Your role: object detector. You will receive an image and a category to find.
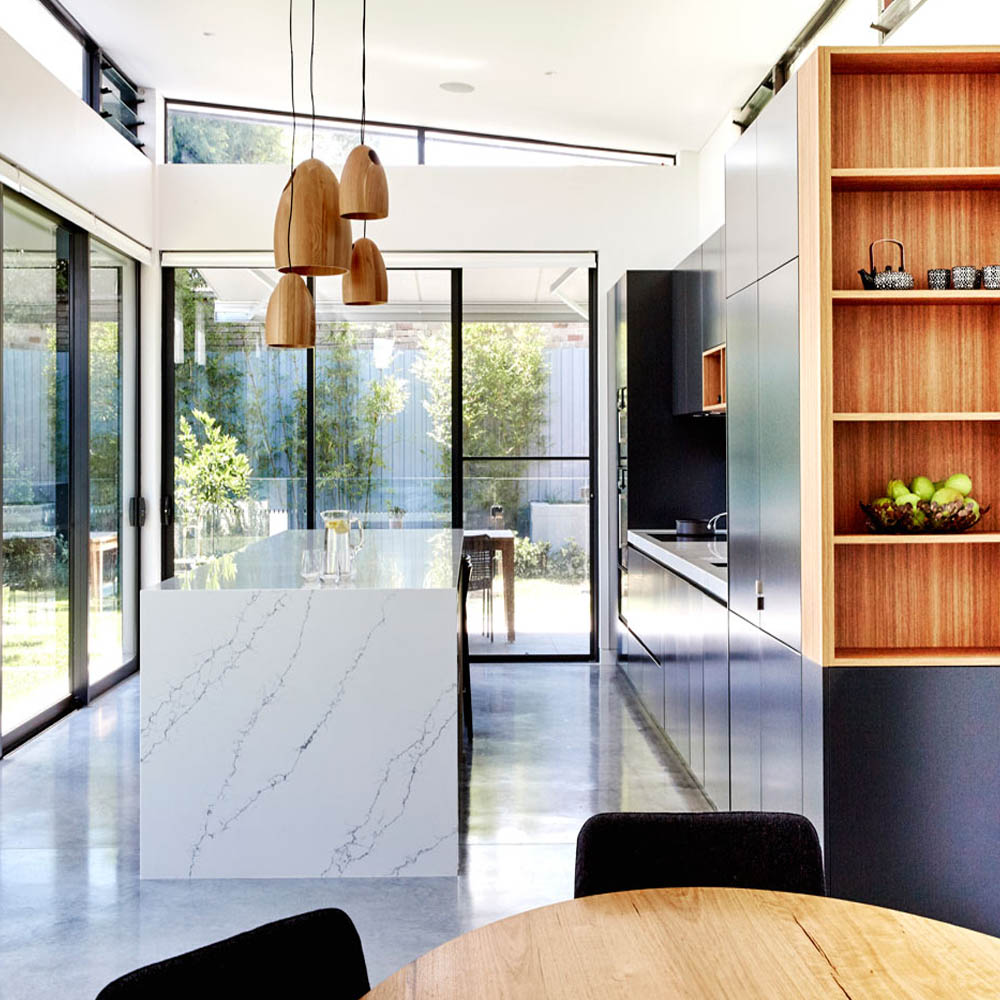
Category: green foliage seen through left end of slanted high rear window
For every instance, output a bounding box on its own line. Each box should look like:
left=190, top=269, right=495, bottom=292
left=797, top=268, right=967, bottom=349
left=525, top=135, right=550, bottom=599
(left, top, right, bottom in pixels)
left=167, top=111, right=288, bottom=163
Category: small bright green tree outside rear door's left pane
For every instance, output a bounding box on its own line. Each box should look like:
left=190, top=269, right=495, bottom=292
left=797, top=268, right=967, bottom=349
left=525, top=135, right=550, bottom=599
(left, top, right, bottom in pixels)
left=174, top=410, right=253, bottom=552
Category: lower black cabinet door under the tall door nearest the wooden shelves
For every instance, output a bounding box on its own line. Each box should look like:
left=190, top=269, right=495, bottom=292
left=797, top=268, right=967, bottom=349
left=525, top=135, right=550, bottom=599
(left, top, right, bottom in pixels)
left=760, top=632, right=802, bottom=813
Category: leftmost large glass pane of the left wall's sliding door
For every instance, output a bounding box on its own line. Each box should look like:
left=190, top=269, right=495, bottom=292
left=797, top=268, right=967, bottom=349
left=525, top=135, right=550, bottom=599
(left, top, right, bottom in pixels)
left=0, top=196, right=70, bottom=732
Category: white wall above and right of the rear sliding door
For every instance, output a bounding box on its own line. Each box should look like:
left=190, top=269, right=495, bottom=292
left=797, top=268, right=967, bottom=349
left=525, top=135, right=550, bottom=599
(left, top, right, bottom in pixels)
left=158, top=156, right=698, bottom=648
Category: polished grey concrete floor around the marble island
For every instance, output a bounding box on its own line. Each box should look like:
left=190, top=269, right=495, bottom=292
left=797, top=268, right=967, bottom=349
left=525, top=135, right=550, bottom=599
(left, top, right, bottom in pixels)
left=0, top=663, right=708, bottom=1000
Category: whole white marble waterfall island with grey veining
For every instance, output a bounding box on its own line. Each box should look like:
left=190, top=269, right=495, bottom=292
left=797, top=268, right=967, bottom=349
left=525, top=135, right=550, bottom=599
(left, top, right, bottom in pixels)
left=139, top=530, right=462, bottom=878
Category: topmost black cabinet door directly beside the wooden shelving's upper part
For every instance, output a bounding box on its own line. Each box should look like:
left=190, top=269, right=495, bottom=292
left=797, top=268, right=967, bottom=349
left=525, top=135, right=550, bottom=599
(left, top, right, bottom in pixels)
left=754, top=76, right=799, bottom=277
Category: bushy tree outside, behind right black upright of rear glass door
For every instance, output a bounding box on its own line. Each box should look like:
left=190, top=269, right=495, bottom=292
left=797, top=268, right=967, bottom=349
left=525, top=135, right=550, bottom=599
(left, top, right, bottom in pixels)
left=415, top=323, right=549, bottom=525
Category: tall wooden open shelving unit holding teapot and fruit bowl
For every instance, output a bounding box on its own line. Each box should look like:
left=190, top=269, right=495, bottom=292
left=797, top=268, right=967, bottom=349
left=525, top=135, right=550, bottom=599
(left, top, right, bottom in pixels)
left=799, top=47, right=1000, bottom=667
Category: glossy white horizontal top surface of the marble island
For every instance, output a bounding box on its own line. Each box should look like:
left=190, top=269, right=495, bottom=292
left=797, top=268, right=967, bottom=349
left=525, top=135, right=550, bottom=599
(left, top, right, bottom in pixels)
left=153, top=528, right=462, bottom=590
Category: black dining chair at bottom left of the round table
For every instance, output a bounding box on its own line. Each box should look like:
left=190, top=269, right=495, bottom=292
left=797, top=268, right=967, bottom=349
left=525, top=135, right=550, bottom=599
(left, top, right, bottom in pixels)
left=97, top=909, right=370, bottom=1000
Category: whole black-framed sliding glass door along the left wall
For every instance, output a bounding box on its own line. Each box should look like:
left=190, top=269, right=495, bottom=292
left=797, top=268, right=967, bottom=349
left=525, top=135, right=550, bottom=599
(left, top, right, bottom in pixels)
left=0, top=191, right=139, bottom=749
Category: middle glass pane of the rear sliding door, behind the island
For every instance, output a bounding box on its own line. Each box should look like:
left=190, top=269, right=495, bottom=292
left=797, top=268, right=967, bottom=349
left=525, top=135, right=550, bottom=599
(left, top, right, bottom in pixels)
left=316, top=270, right=451, bottom=528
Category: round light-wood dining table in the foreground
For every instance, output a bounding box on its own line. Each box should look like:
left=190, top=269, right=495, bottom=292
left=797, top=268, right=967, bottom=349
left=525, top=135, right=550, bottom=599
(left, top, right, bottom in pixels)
left=368, top=889, right=1000, bottom=1000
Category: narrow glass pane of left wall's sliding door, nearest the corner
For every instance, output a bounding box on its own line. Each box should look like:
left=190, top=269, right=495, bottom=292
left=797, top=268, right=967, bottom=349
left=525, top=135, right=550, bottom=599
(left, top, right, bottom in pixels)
left=87, top=240, right=138, bottom=684
